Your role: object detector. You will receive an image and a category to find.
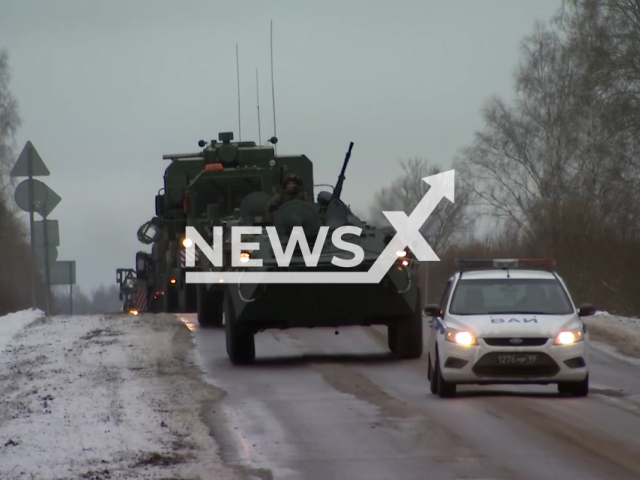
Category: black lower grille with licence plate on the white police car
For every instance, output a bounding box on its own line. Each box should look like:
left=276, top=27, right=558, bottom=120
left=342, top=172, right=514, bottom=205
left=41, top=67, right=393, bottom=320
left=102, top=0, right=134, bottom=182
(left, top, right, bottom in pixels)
left=473, top=351, right=560, bottom=377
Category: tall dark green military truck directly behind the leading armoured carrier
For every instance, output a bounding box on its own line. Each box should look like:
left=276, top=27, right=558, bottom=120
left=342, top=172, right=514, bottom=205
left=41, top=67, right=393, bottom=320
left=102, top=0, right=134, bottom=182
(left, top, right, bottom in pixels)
left=176, top=132, right=313, bottom=327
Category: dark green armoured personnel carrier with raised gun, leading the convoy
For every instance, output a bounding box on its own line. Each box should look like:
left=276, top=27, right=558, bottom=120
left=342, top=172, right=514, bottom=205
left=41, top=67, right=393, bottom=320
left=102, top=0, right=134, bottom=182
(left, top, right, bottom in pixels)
left=218, top=144, right=425, bottom=364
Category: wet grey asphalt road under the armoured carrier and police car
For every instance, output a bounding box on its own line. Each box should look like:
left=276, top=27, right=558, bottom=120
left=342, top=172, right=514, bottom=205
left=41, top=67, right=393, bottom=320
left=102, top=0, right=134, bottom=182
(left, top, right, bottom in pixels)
left=180, top=315, right=640, bottom=480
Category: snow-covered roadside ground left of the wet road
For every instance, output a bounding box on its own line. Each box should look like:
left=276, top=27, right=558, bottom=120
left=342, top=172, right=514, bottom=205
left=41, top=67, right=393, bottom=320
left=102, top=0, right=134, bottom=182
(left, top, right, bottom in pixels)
left=0, top=311, right=240, bottom=480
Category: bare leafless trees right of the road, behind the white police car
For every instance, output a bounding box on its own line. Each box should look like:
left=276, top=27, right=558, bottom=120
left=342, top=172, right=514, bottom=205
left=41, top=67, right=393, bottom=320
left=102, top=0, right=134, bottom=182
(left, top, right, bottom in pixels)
left=372, top=0, right=640, bottom=315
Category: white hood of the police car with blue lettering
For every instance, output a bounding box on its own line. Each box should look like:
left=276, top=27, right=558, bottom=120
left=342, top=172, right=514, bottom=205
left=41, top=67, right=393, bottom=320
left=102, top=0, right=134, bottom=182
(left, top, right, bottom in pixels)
left=445, top=313, right=582, bottom=337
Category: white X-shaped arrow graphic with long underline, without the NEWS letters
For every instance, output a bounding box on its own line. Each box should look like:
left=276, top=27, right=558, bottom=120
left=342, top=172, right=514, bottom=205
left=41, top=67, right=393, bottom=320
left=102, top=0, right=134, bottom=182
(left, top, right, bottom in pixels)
left=185, top=170, right=455, bottom=284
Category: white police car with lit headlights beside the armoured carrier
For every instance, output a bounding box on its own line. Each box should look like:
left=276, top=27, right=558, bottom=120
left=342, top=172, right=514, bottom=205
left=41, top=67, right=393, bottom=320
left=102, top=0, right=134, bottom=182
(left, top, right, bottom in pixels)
left=425, top=259, right=595, bottom=397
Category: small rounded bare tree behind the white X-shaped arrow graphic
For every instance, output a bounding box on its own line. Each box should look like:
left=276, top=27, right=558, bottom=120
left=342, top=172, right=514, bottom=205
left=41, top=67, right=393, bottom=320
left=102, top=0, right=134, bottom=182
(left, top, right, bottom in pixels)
left=371, top=158, right=471, bottom=252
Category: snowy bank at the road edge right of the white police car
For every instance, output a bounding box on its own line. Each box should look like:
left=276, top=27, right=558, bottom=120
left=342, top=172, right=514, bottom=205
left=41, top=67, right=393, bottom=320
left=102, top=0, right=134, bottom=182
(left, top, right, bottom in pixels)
left=584, top=312, right=640, bottom=357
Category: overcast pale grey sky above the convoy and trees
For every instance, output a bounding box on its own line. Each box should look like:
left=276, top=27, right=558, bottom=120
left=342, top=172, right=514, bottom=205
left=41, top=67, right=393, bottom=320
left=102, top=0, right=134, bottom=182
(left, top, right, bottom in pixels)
left=0, top=0, right=561, bottom=290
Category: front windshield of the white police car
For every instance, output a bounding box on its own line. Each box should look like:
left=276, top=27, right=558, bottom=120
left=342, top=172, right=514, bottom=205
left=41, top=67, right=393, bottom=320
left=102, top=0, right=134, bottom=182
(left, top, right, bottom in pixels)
left=449, top=278, right=574, bottom=315
